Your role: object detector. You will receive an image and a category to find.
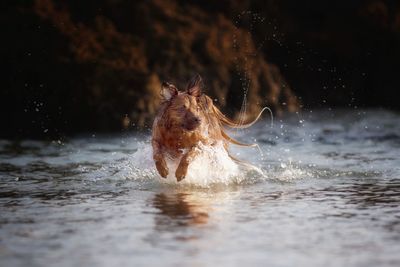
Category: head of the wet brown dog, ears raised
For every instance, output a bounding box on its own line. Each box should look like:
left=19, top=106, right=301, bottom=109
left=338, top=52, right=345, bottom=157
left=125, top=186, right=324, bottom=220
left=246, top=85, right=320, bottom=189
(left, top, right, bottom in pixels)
left=161, top=75, right=206, bottom=131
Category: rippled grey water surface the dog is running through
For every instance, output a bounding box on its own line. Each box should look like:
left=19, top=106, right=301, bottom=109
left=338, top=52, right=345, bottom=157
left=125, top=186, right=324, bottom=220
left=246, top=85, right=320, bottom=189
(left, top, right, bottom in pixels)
left=0, top=110, right=400, bottom=266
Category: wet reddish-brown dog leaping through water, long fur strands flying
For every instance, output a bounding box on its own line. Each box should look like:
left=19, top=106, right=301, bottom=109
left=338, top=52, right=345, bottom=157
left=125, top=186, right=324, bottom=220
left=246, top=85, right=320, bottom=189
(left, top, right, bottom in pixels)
left=152, top=75, right=261, bottom=181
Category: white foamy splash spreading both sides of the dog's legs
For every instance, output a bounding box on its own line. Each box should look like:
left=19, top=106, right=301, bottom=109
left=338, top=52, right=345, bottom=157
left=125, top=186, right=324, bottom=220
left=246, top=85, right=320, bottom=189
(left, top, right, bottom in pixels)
left=85, top=141, right=312, bottom=188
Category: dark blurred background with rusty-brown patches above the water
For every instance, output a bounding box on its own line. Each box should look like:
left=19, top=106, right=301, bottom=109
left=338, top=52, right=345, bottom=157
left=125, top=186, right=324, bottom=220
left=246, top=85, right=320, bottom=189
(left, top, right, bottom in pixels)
left=0, top=0, right=400, bottom=139
